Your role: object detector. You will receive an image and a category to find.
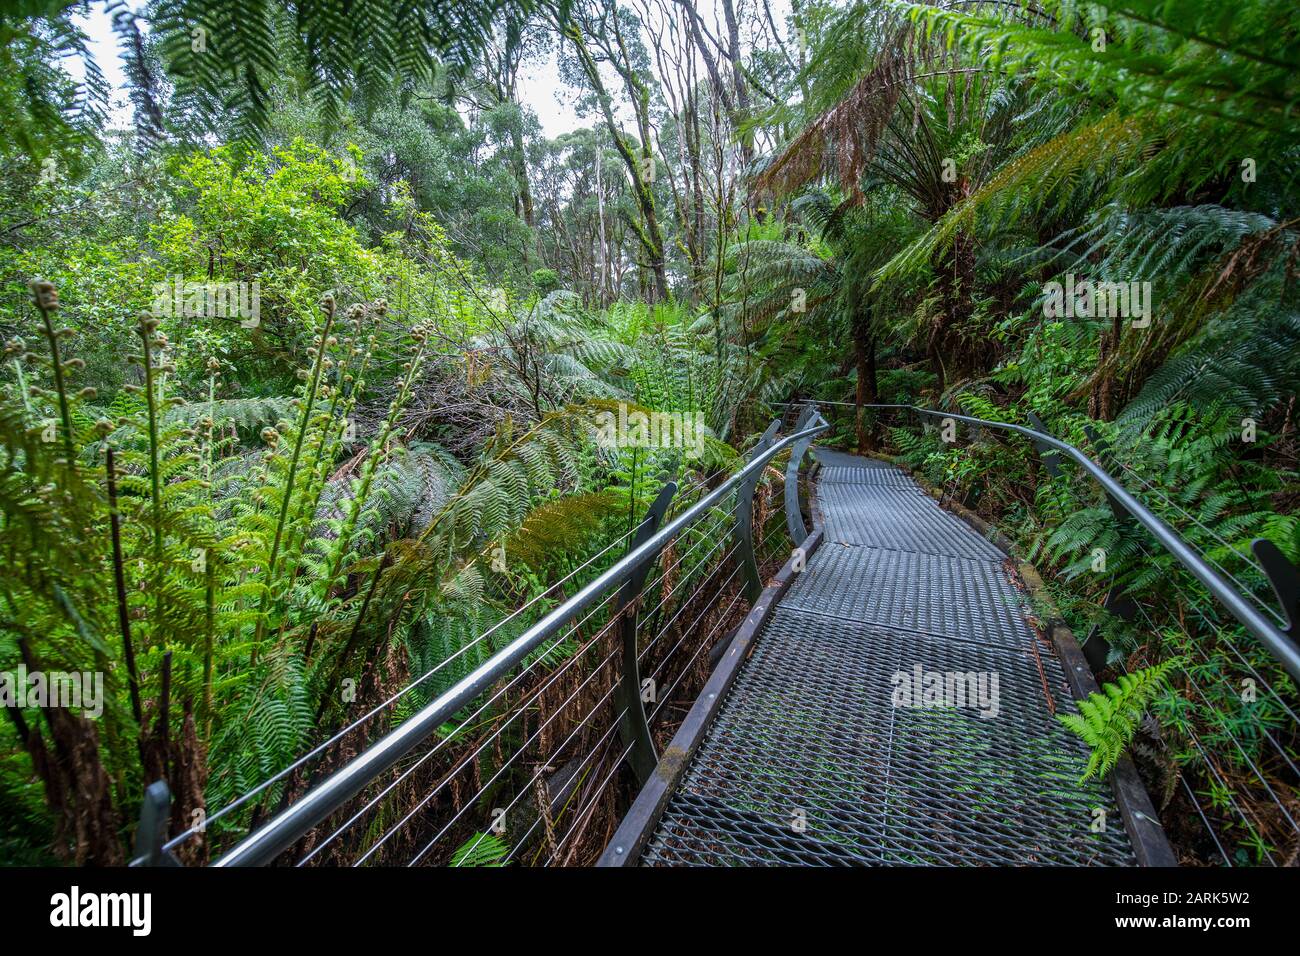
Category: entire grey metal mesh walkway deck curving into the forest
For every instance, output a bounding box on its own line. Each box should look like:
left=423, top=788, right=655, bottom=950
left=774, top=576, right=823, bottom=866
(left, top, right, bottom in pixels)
left=641, top=453, right=1134, bottom=865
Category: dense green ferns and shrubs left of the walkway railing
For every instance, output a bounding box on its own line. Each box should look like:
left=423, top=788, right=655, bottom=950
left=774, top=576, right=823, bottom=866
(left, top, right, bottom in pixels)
left=3, top=143, right=769, bottom=862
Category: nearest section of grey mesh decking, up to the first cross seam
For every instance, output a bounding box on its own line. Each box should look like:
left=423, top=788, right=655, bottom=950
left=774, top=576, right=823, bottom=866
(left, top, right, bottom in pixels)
left=642, top=606, right=1134, bottom=866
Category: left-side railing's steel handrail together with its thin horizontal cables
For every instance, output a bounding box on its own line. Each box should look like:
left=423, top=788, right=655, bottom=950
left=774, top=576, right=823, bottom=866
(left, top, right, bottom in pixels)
left=157, top=420, right=828, bottom=866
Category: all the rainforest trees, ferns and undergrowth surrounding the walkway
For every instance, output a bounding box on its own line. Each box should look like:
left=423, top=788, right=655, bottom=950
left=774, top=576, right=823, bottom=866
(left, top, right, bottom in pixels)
left=0, top=0, right=1300, bottom=865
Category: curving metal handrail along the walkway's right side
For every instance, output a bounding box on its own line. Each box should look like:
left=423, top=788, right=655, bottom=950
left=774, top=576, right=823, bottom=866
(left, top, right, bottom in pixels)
left=810, top=399, right=1300, bottom=684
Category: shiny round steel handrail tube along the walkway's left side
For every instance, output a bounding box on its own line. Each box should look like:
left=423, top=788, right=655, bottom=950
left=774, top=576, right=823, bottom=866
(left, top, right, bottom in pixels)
left=213, top=419, right=829, bottom=866
